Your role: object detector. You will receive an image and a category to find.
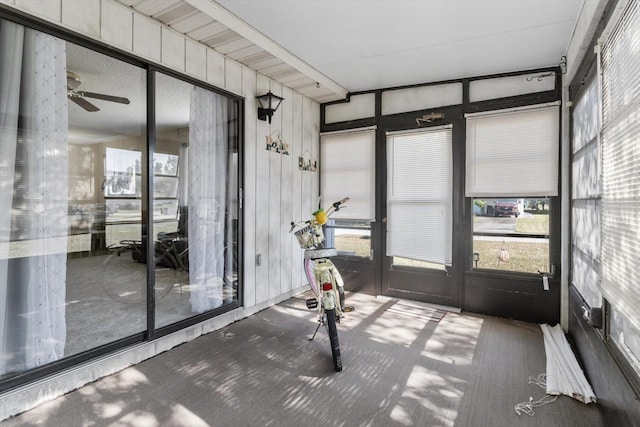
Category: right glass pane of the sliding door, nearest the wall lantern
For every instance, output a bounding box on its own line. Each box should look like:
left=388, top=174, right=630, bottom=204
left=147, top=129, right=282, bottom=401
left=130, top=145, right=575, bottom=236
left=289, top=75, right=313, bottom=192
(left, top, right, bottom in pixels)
left=153, top=74, right=238, bottom=327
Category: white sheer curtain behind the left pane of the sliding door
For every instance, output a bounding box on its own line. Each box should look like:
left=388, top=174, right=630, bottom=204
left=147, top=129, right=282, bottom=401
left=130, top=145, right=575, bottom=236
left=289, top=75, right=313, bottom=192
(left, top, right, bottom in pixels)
left=0, top=20, right=68, bottom=375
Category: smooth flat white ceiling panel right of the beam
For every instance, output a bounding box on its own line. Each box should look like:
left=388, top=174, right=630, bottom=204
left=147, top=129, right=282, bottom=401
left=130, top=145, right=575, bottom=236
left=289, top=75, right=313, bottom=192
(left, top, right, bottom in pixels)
left=219, top=0, right=584, bottom=92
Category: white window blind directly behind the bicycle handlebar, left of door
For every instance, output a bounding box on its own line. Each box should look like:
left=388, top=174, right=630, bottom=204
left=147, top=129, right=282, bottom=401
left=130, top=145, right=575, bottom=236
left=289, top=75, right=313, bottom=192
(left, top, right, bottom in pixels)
left=320, top=128, right=376, bottom=221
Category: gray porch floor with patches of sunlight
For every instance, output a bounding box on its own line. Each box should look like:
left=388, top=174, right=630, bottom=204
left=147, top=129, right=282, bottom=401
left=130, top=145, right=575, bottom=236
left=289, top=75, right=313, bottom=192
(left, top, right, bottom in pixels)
left=0, top=294, right=604, bottom=427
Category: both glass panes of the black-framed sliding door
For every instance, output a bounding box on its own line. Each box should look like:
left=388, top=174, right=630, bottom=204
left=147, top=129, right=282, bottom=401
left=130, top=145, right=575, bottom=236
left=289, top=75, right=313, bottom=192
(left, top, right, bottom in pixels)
left=0, top=34, right=238, bottom=378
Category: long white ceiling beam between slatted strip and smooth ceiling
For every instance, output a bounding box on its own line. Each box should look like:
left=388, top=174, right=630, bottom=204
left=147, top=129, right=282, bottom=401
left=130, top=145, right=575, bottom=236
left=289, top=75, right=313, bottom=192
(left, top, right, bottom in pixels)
left=185, top=0, right=349, bottom=99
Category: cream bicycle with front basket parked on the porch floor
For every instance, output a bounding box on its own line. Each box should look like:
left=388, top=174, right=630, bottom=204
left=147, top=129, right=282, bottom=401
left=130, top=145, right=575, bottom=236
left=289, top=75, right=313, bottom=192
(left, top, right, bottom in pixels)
left=289, top=197, right=354, bottom=372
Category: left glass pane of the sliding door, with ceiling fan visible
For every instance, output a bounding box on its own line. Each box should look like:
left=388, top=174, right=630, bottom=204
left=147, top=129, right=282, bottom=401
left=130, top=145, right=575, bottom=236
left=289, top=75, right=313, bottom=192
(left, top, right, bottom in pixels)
left=0, top=20, right=146, bottom=379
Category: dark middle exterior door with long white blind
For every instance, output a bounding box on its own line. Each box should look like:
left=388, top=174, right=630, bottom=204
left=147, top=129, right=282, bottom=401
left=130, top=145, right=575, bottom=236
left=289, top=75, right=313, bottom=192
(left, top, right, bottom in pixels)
left=381, top=125, right=460, bottom=306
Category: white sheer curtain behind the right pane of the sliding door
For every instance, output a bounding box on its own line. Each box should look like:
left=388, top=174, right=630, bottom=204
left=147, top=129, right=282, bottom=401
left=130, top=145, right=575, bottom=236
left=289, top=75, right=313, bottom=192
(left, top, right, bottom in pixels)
left=188, top=87, right=229, bottom=313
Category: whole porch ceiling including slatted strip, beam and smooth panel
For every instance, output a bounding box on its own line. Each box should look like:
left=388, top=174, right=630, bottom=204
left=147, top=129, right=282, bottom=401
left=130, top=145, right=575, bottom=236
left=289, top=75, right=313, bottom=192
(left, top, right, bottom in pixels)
left=117, top=0, right=598, bottom=103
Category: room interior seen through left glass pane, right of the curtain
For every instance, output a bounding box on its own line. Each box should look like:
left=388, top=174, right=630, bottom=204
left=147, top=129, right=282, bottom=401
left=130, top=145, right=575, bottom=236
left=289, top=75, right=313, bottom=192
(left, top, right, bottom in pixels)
left=65, top=43, right=147, bottom=356
